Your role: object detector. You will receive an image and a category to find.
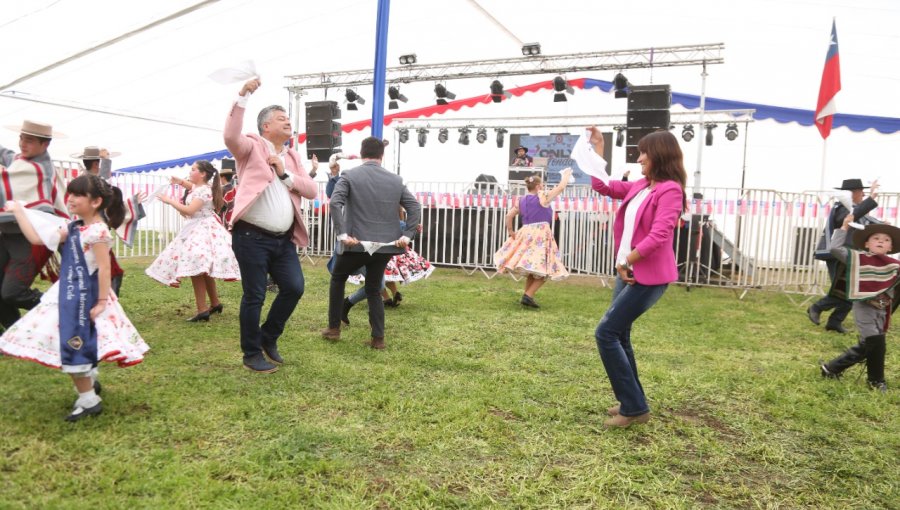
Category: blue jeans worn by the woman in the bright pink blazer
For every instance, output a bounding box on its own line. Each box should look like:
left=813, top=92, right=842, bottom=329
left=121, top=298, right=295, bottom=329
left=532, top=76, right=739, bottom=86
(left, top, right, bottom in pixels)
left=594, top=278, right=668, bottom=416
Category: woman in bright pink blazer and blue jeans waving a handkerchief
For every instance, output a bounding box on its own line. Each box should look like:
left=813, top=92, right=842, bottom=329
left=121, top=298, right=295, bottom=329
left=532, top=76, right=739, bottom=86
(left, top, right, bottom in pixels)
left=590, top=128, right=687, bottom=427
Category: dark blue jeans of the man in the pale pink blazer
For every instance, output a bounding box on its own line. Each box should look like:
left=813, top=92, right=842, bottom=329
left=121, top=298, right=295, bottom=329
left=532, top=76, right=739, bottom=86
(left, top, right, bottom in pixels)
left=231, top=225, right=304, bottom=359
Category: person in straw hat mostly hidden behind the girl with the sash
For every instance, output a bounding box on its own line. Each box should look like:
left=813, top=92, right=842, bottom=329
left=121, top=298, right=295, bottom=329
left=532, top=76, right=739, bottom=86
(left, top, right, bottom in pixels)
left=72, top=146, right=147, bottom=297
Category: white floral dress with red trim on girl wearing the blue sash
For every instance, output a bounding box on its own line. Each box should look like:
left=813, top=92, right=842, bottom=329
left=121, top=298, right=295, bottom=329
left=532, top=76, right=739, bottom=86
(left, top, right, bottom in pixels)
left=0, top=223, right=150, bottom=368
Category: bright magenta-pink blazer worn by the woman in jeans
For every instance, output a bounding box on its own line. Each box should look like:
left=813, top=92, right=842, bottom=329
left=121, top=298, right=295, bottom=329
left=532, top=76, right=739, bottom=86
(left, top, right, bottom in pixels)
left=591, top=177, right=684, bottom=285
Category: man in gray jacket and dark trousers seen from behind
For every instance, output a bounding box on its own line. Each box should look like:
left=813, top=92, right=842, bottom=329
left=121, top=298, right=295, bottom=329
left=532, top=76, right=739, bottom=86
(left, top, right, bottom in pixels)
left=322, top=137, right=422, bottom=349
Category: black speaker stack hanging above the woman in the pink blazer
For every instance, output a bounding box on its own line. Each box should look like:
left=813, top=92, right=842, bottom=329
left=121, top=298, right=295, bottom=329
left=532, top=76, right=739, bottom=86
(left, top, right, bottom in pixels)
left=625, top=85, right=672, bottom=163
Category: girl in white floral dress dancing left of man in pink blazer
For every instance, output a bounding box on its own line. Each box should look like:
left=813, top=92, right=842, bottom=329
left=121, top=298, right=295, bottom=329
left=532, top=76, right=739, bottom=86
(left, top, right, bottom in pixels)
left=145, top=160, right=241, bottom=322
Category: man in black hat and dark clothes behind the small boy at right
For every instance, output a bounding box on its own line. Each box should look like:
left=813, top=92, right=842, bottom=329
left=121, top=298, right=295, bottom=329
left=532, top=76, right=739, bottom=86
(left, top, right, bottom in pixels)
left=806, top=179, right=878, bottom=333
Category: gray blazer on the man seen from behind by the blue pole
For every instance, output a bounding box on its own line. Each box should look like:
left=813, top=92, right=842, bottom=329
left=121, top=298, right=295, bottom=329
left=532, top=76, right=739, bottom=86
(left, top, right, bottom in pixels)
left=329, top=161, right=422, bottom=254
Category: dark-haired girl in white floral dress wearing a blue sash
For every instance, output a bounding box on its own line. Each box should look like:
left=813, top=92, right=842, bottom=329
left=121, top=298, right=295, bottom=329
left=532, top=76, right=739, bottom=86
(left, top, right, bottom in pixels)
left=0, top=174, right=150, bottom=422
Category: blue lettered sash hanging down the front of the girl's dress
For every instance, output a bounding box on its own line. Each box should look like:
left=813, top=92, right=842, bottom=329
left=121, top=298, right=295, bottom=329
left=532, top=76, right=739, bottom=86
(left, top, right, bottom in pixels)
left=59, top=221, right=99, bottom=372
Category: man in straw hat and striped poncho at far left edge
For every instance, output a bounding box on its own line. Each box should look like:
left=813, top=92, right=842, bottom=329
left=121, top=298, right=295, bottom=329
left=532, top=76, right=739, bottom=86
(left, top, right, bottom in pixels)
left=0, top=120, right=68, bottom=328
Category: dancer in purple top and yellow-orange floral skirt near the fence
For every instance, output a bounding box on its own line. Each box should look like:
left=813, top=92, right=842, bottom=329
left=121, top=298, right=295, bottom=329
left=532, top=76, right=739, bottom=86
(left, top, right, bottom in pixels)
left=494, top=168, right=572, bottom=308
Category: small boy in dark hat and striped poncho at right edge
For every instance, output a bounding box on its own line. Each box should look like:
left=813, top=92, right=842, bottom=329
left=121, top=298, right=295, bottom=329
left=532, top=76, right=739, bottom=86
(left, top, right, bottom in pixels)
left=819, top=214, right=900, bottom=392
